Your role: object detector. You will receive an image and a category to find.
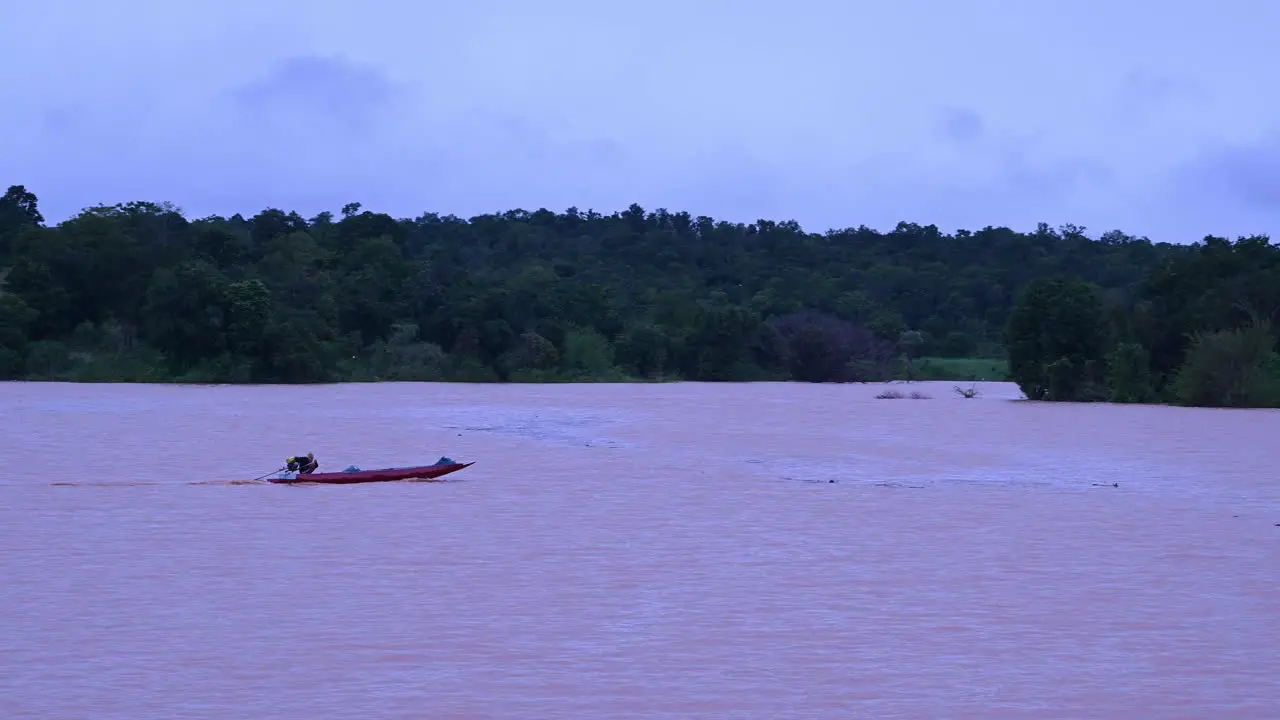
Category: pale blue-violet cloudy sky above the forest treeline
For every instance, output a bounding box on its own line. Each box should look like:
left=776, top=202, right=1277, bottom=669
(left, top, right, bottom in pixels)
left=0, top=0, right=1280, bottom=242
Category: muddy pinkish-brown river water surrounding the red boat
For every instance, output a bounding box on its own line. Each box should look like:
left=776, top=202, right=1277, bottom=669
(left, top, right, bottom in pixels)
left=0, top=383, right=1280, bottom=719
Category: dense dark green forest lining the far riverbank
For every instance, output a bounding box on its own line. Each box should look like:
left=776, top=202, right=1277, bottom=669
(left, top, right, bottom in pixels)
left=0, top=186, right=1280, bottom=405
